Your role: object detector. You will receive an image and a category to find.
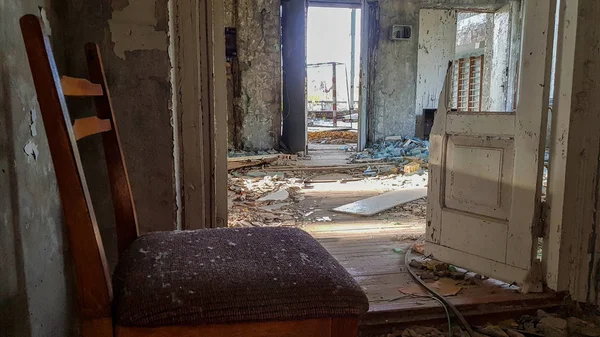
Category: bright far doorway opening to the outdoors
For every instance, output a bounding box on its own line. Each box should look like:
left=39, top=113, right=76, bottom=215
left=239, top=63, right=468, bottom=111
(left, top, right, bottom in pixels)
left=306, top=6, right=361, bottom=150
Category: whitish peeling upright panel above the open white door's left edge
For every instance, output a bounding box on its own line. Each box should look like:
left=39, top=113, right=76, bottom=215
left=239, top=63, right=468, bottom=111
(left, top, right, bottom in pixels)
left=415, top=9, right=456, bottom=136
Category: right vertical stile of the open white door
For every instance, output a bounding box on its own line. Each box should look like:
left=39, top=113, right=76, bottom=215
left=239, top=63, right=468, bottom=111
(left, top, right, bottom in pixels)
left=506, top=0, right=556, bottom=269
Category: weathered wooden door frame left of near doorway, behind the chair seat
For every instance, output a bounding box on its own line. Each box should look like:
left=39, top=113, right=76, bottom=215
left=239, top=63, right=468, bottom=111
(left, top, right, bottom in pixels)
left=169, top=0, right=227, bottom=229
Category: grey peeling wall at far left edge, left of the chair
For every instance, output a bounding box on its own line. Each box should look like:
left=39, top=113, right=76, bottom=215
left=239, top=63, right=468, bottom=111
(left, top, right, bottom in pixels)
left=0, top=0, right=77, bottom=337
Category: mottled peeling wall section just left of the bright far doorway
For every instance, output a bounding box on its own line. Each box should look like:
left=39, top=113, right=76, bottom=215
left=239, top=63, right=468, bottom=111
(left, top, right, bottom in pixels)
left=224, top=0, right=281, bottom=150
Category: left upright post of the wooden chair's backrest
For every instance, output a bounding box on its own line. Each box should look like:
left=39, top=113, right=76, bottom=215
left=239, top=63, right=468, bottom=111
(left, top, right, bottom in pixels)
left=20, top=15, right=112, bottom=319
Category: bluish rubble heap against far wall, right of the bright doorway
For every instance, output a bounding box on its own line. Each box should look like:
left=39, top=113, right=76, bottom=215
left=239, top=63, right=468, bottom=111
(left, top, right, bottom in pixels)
left=351, top=136, right=429, bottom=163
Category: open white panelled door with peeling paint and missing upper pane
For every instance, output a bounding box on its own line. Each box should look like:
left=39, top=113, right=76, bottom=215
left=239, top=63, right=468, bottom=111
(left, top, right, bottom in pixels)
left=425, top=0, right=556, bottom=292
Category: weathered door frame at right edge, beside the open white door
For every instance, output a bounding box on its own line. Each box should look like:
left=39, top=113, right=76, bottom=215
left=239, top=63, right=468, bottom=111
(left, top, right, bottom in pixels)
left=542, top=0, right=600, bottom=304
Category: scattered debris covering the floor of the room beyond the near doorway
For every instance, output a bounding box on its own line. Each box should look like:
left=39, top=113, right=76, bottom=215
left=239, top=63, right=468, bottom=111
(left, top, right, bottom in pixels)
left=228, top=144, right=428, bottom=226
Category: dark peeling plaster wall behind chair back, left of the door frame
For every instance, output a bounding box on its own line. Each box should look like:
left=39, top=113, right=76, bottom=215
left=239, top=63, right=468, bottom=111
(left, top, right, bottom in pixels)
left=66, top=0, right=177, bottom=265
